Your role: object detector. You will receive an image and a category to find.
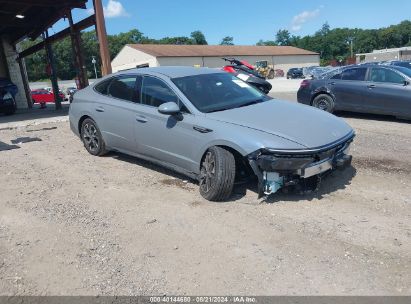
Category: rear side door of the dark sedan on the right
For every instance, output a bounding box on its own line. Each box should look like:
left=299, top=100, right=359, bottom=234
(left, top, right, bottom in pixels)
left=327, top=67, right=367, bottom=111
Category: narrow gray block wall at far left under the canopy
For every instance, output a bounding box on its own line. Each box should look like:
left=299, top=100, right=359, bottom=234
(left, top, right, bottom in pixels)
left=0, top=38, right=28, bottom=109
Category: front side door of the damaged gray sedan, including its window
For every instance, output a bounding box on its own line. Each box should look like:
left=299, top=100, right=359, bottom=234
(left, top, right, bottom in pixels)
left=135, top=76, right=201, bottom=172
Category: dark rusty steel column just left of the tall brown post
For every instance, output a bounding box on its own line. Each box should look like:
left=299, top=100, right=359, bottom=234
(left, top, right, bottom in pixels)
left=67, top=11, right=88, bottom=89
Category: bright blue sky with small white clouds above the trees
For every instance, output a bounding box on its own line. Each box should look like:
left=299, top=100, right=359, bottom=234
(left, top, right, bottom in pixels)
left=51, top=0, right=411, bottom=45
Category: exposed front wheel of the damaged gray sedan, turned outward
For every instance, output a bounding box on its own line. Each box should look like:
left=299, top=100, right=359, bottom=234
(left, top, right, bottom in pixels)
left=200, top=146, right=236, bottom=202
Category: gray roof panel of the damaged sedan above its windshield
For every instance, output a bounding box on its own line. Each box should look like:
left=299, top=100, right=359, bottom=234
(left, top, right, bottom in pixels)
left=117, top=66, right=224, bottom=78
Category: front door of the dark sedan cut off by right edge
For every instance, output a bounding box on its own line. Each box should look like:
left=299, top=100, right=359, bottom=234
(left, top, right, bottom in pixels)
left=365, top=67, right=411, bottom=116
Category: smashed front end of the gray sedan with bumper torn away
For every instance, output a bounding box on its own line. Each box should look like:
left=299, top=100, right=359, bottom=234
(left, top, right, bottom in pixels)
left=248, top=133, right=355, bottom=197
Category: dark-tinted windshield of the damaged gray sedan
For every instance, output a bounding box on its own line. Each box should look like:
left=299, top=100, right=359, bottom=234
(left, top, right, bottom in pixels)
left=172, top=73, right=271, bottom=113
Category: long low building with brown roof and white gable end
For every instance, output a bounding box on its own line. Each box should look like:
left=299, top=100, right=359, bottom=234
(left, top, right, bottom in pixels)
left=111, top=44, right=320, bottom=72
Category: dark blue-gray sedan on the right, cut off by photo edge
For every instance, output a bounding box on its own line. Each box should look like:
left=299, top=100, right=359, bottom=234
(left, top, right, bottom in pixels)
left=297, top=65, right=411, bottom=119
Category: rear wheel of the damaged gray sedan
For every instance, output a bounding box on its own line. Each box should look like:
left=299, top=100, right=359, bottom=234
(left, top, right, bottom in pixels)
left=80, top=118, right=107, bottom=156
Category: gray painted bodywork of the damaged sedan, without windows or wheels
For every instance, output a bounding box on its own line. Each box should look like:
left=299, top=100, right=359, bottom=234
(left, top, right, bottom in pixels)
left=69, top=67, right=353, bottom=176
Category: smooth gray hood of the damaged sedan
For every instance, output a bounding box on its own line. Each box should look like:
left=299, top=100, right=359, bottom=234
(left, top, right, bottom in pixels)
left=207, top=99, right=353, bottom=149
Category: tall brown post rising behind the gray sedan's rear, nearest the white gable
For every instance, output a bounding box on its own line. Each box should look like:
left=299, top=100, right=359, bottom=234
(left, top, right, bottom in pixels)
left=93, top=0, right=112, bottom=76
